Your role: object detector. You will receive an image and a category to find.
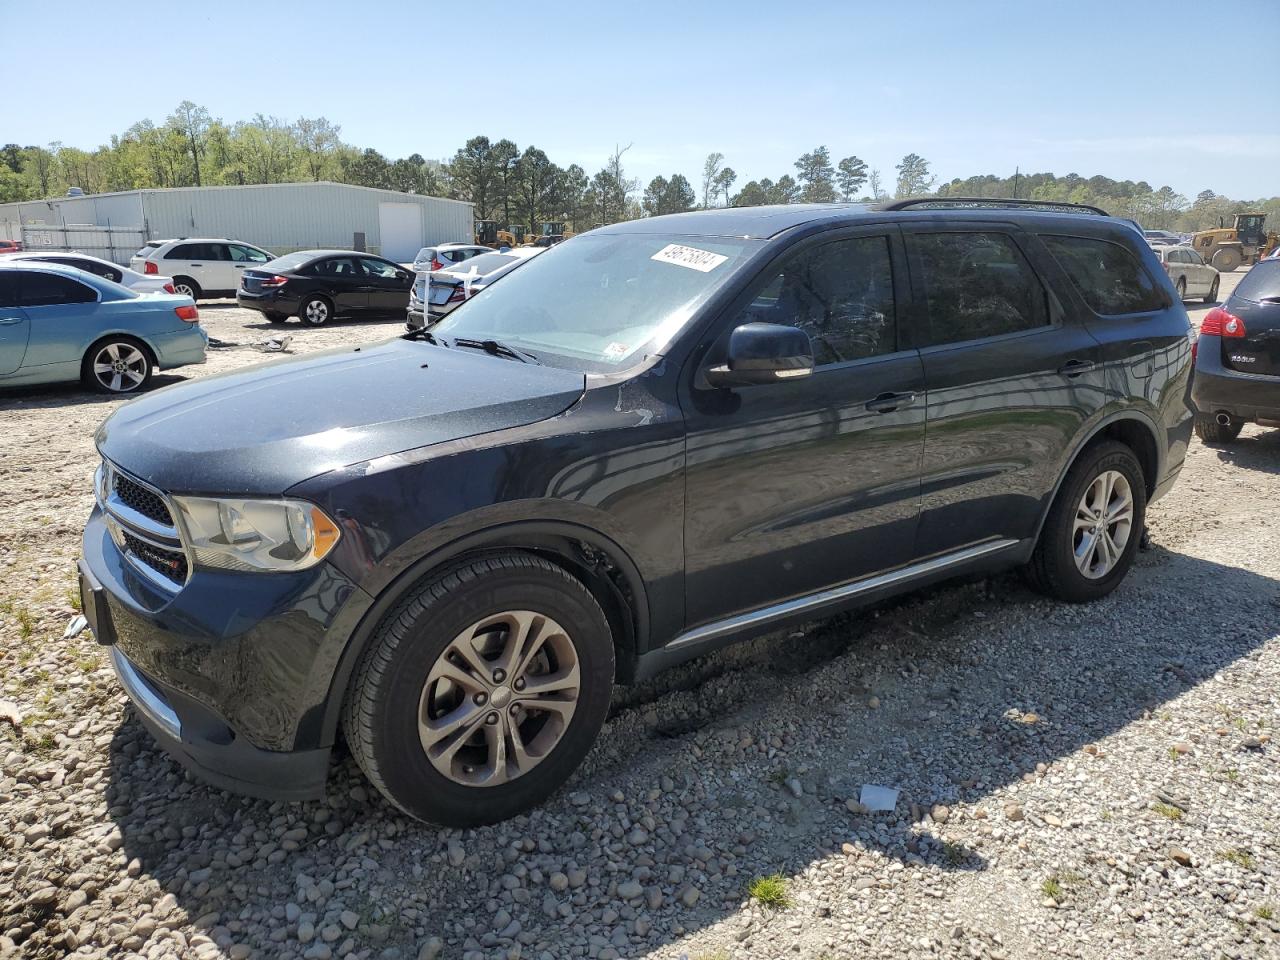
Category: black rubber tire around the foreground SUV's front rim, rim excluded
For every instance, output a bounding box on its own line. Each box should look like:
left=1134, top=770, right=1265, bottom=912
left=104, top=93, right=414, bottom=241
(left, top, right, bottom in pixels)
left=343, top=553, right=613, bottom=827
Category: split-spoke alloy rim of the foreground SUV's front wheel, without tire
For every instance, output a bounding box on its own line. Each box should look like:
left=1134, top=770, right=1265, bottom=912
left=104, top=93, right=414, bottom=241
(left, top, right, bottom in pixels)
left=417, top=611, right=581, bottom=787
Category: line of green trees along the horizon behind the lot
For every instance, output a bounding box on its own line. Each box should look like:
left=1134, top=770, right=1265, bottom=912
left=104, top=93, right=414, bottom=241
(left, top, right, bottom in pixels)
left=0, top=100, right=1280, bottom=232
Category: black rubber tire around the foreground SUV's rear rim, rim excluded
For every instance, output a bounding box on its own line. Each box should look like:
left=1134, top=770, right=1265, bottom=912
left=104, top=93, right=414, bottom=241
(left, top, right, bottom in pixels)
left=1027, top=440, right=1147, bottom=603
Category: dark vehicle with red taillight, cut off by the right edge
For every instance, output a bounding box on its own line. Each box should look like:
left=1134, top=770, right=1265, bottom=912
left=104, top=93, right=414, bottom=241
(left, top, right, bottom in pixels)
left=1192, top=260, right=1280, bottom=443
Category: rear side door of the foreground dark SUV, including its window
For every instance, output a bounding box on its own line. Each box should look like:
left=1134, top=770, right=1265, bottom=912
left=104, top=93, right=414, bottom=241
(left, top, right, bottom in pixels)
left=904, top=221, right=1105, bottom=556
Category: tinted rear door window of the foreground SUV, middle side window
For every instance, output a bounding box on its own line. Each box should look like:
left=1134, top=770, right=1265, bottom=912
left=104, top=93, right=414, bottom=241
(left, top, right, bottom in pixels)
left=914, top=232, right=1050, bottom=346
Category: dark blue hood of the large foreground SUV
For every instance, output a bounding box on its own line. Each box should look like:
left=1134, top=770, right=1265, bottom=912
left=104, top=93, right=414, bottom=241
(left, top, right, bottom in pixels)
left=97, top=339, right=585, bottom=495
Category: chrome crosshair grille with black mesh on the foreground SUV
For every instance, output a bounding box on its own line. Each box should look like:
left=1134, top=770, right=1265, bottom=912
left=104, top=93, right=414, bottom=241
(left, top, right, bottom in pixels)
left=93, top=460, right=191, bottom=591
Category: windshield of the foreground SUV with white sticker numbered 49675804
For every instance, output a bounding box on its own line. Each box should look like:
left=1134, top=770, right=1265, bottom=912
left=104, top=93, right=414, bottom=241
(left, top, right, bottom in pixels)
left=431, top=233, right=759, bottom=374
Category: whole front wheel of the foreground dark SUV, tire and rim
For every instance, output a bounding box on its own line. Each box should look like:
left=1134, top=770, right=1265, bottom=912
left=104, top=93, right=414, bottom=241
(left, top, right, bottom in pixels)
left=343, top=553, right=613, bottom=827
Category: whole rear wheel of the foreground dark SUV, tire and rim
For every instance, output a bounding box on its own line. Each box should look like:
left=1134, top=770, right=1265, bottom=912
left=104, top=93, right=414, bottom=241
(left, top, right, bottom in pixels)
left=1027, top=440, right=1147, bottom=603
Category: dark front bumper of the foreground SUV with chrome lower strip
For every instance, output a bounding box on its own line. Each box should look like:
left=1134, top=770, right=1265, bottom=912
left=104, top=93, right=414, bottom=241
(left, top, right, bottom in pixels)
left=81, top=508, right=369, bottom=800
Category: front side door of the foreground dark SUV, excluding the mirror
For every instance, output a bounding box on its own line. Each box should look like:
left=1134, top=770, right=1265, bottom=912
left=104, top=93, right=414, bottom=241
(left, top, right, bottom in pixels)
left=680, top=225, right=924, bottom=626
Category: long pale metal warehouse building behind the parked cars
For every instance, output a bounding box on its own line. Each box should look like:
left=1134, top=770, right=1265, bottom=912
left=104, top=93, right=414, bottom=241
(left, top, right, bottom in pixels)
left=0, top=182, right=474, bottom=264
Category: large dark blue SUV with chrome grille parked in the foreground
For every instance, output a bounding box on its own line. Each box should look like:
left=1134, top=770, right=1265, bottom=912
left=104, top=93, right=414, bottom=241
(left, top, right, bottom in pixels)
left=81, top=201, right=1192, bottom=824
